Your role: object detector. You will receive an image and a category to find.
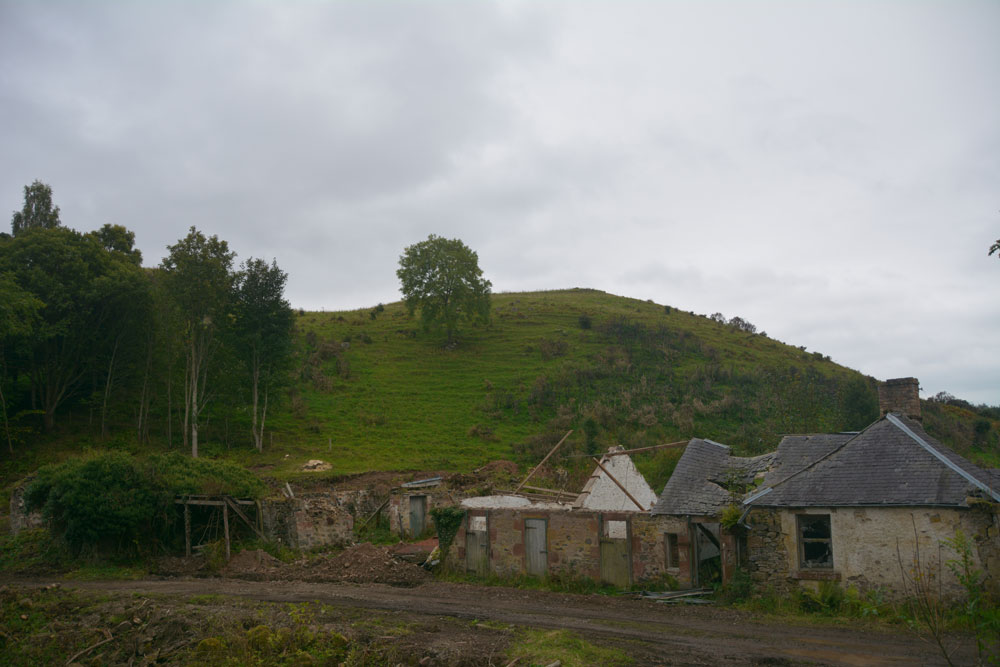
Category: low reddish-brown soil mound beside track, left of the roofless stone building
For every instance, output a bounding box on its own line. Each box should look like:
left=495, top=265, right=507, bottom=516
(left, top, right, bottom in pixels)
left=276, top=542, right=429, bottom=586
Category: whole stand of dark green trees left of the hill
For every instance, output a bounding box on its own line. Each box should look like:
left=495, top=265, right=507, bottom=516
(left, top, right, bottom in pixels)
left=0, top=181, right=294, bottom=457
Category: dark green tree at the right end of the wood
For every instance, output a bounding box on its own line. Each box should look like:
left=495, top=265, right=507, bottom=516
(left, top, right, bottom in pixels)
left=234, top=258, right=295, bottom=451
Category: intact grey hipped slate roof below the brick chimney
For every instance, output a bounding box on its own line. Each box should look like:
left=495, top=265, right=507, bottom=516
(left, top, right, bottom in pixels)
left=745, top=414, right=1000, bottom=507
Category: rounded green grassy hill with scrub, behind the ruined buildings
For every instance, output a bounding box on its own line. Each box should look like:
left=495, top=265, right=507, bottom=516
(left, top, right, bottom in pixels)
left=8, top=289, right=1000, bottom=490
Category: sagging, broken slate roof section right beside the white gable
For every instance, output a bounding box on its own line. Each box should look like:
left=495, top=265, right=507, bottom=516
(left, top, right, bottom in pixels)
left=651, top=438, right=774, bottom=516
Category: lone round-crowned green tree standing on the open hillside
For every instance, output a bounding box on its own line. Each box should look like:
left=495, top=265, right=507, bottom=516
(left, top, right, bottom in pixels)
left=396, top=234, right=491, bottom=344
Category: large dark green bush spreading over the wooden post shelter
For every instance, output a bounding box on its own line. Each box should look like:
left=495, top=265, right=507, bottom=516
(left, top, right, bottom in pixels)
left=25, top=452, right=265, bottom=554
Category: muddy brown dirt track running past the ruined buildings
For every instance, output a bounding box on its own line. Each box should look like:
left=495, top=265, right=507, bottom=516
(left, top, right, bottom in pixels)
left=35, top=578, right=972, bottom=665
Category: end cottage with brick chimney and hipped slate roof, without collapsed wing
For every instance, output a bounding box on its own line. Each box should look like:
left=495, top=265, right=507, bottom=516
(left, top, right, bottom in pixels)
left=741, top=378, right=1000, bottom=596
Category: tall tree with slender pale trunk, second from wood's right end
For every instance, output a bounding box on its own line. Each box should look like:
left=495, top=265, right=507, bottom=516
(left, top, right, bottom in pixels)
left=160, top=227, right=235, bottom=458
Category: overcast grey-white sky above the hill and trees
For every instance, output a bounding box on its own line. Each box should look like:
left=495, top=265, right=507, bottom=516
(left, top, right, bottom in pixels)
left=0, top=0, right=1000, bottom=404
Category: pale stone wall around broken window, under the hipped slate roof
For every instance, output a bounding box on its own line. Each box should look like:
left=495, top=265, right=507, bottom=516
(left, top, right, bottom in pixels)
left=747, top=506, right=1000, bottom=598
